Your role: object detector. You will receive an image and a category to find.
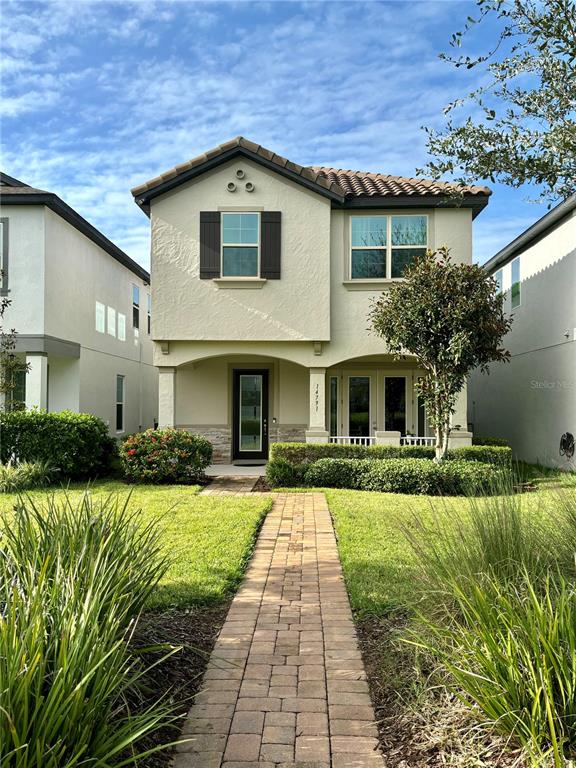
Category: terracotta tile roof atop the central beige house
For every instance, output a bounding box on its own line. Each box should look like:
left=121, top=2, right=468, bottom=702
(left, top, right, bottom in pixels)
left=132, top=136, right=491, bottom=204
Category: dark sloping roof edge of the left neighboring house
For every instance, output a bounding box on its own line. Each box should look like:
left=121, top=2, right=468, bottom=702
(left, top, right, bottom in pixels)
left=0, top=172, right=150, bottom=284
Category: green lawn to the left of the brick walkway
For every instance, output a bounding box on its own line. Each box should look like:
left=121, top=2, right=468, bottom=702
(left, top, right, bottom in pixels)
left=0, top=482, right=271, bottom=609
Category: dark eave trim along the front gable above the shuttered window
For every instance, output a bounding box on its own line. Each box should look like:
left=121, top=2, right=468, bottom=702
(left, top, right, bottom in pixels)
left=132, top=146, right=345, bottom=216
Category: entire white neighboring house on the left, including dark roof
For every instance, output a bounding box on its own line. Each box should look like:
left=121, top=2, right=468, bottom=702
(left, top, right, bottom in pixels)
left=0, top=174, right=158, bottom=435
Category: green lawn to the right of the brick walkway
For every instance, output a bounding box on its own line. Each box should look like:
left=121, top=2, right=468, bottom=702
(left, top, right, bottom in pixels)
left=325, top=464, right=574, bottom=615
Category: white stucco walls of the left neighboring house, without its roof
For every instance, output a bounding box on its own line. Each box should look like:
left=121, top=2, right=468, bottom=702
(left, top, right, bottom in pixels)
left=1, top=205, right=158, bottom=435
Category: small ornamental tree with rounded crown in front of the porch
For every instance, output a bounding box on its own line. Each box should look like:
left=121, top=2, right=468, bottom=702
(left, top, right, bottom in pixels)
left=369, top=248, right=511, bottom=461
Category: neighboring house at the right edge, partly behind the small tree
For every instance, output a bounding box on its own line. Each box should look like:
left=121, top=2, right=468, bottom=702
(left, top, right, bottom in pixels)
left=468, top=195, right=576, bottom=468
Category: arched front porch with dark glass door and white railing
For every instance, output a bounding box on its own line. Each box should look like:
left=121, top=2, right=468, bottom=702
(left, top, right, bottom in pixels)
left=159, top=355, right=471, bottom=465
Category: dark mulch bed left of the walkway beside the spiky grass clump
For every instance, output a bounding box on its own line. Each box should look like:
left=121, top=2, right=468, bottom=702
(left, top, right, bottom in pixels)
left=132, top=602, right=229, bottom=768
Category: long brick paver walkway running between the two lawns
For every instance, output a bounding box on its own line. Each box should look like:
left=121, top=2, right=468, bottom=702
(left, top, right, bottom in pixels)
left=174, top=493, right=384, bottom=768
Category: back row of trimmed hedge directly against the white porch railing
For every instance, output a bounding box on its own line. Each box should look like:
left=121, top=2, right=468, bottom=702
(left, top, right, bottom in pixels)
left=270, top=443, right=512, bottom=467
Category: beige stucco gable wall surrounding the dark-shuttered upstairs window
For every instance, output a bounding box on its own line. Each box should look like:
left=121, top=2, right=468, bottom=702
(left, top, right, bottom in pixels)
left=151, top=159, right=330, bottom=341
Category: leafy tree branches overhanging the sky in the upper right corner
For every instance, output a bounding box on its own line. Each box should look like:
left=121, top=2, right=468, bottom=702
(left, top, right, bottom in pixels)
left=418, top=0, right=576, bottom=202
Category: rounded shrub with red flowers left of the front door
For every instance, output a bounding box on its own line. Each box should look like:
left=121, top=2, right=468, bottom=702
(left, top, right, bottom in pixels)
left=120, top=429, right=212, bottom=484
